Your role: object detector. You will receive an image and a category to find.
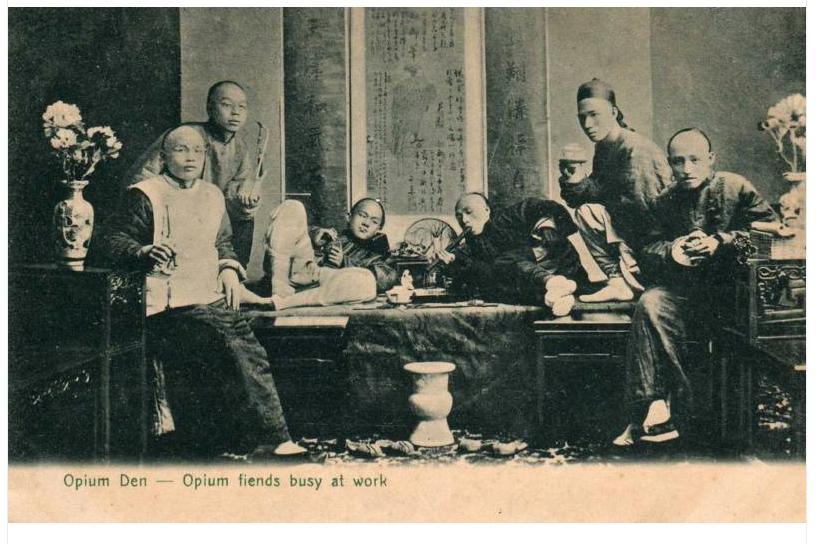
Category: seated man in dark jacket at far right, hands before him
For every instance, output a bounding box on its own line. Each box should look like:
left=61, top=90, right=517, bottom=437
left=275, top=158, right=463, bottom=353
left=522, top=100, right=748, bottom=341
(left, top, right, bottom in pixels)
left=613, top=128, right=776, bottom=446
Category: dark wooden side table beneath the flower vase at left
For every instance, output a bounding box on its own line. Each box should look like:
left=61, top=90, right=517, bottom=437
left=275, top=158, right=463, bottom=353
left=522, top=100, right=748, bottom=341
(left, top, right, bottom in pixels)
left=9, top=265, right=147, bottom=459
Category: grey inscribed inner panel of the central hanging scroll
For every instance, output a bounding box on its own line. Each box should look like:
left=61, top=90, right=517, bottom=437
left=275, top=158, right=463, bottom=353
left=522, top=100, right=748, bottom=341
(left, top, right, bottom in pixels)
left=365, top=8, right=467, bottom=215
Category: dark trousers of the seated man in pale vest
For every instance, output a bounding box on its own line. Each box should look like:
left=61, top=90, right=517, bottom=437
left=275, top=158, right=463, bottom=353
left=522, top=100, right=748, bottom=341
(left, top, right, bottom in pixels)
left=147, top=299, right=290, bottom=447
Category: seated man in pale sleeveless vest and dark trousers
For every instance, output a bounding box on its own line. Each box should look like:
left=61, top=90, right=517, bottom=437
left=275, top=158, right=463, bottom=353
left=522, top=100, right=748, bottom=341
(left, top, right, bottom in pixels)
left=106, top=125, right=305, bottom=455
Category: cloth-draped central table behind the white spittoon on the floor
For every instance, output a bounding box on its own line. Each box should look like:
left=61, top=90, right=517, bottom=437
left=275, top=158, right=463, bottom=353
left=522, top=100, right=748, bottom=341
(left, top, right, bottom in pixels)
left=153, top=302, right=547, bottom=436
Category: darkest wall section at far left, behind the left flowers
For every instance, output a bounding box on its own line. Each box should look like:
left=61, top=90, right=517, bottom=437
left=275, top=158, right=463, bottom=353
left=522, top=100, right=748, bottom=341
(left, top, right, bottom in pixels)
left=8, top=8, right=180, bottom=262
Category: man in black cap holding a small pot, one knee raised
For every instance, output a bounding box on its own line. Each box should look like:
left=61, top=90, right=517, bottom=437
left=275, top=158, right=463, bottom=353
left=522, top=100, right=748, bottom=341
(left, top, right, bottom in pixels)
left=560, top=79, right=672, bottom=302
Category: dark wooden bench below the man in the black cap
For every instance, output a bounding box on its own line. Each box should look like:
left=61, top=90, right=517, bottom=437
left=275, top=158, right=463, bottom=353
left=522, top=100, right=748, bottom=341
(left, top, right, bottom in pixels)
left=534, top=302, right=716, bottom=442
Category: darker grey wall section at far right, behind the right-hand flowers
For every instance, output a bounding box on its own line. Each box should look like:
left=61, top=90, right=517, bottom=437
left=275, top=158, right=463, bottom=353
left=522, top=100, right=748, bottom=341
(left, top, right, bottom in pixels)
left=650, top=8, right=806, bottom=202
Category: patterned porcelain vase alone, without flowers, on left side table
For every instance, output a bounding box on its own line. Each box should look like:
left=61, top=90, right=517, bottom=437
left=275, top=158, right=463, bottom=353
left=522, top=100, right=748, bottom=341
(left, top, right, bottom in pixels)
left=54, top=179, right=94, bottom=271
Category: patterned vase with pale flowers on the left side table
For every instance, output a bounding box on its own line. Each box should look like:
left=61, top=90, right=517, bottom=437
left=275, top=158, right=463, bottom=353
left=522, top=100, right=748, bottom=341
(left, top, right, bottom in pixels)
left=43, top=101, right=123, bottom=270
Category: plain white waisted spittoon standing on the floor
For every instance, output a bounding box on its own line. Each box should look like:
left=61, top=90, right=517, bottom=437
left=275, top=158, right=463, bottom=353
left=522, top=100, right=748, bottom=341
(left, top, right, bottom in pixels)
left=403, top=362, right=455, bottom=447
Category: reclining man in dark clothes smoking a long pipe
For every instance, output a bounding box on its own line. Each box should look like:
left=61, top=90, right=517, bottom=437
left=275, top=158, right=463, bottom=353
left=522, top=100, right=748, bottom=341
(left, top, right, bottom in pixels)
left=436, top=193, right=587, bottom=316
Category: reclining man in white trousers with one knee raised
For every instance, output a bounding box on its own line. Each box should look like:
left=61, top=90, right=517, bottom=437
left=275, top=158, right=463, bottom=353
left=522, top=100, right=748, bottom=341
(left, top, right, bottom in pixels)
left=251, top=197, right=398, bottom=310
